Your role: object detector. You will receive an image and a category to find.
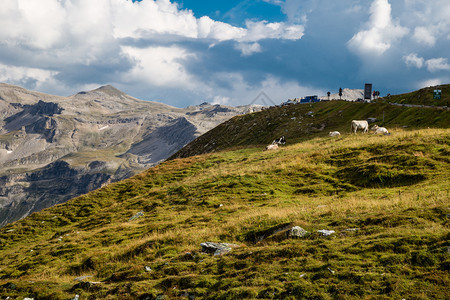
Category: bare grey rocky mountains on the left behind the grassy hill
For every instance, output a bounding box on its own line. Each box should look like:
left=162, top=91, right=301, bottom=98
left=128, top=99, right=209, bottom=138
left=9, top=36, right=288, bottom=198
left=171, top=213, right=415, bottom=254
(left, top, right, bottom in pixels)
left=0, top=84, right=258, bottom=226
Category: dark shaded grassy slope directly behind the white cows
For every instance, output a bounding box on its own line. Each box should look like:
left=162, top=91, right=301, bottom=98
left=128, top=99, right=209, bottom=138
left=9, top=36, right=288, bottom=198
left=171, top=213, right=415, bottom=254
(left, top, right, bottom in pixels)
left=172, top=101, right=450, bottom=158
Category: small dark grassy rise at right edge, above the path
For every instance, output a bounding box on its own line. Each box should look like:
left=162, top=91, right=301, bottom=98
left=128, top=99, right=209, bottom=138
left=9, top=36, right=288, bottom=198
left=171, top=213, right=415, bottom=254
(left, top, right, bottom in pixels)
left=378, top=84, right=450, bottom=107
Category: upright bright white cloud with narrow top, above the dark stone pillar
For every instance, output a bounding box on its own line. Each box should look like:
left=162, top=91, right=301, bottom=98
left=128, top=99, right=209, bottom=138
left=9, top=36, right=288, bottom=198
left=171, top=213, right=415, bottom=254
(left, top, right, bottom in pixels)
left=347, top=0, right=408, bottom=57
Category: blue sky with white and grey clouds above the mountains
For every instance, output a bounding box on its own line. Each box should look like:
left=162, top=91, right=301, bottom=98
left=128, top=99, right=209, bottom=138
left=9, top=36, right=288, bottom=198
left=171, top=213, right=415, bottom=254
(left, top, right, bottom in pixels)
left=0, top=0, right=450, bottom=107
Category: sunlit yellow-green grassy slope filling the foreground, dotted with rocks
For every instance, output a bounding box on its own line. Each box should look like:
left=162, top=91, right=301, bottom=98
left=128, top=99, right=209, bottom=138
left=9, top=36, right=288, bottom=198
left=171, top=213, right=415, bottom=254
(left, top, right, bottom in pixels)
left=0, top=127, right=450, bottom=299
